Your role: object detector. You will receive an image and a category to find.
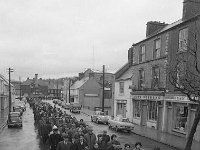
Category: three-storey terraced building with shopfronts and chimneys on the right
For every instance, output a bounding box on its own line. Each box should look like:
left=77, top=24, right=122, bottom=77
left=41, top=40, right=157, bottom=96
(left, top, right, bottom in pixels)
left=129, top=0, right=200, bottom=141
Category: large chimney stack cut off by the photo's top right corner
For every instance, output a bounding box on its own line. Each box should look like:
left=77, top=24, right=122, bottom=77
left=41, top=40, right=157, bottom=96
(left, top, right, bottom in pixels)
left=182, top=0, right=200, bottom=21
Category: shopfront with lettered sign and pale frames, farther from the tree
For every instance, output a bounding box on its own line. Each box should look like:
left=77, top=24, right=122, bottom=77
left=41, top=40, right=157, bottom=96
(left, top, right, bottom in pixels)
left=132, top=95, right=164, bottom=130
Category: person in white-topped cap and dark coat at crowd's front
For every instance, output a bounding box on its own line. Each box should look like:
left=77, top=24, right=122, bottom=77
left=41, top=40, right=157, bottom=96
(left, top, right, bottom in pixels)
left=49, top=125, right=62, bottom=150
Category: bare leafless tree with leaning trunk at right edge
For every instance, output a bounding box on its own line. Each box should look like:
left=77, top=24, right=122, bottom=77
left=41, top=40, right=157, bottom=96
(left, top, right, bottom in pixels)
left=168, top=17, right=200, bottom=150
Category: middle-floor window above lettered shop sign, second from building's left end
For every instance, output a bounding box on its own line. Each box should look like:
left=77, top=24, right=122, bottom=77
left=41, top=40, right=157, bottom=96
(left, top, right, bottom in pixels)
left=152, top=66, right=160, bottom=88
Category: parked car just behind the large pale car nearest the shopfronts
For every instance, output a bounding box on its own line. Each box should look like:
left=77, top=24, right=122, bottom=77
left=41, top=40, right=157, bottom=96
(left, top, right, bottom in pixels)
left=91, top=111, right=111, bottom=124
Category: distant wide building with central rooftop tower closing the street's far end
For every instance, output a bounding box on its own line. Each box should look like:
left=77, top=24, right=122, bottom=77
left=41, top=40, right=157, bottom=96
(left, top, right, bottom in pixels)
left=21, top=74, right=48, bottom=97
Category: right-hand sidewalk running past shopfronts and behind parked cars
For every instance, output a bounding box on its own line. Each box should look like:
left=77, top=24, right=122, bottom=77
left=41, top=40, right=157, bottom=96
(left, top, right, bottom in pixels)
left=81, top=108, right=200, bottom=150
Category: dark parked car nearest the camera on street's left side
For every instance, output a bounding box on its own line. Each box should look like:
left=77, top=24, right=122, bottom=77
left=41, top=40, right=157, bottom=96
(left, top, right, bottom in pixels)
left=7, top=112, right=22, bottom=128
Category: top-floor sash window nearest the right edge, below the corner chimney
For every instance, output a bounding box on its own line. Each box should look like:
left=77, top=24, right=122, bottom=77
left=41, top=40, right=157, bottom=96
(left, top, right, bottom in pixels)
left=178, top=28, right=188, bottom=51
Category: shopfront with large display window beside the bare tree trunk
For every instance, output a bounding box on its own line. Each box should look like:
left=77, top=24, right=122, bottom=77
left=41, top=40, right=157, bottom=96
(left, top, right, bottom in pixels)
left=165, top=94, right=200, bottom=141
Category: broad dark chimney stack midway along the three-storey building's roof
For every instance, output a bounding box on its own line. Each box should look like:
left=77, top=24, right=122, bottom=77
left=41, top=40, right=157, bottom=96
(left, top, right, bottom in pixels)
left=146, top=21, right=167, bottom=37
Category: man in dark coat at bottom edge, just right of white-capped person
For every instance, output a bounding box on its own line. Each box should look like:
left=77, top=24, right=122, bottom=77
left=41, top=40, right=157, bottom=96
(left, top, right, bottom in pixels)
left=56, top=134, right=72, bottom=150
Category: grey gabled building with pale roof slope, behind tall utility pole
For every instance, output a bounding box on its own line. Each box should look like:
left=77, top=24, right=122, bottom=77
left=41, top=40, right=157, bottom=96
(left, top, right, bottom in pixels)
left=67, top=69, right=114, bottom=115
